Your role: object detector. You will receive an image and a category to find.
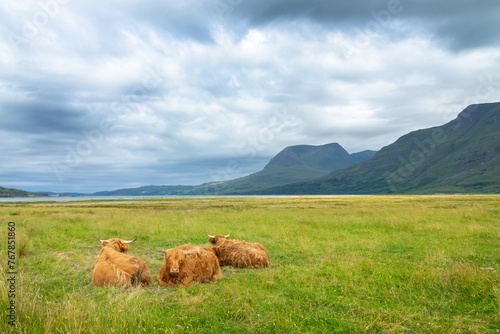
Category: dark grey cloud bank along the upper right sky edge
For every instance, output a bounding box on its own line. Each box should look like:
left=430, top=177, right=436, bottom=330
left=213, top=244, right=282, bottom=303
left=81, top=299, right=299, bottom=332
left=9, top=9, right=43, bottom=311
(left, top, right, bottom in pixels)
left=228, top=0, right=500, bottom=51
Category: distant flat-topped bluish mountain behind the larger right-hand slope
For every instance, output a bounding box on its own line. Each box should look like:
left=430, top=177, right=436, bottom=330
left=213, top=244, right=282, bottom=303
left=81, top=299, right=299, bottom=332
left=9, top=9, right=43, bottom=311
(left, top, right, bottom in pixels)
left=189, top=143, right=376, bottom=195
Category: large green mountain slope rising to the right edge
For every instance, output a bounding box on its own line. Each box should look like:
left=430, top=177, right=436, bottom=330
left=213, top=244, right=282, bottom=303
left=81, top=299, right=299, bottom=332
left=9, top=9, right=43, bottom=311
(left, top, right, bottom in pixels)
left=261, top=103, right=500, bottom=194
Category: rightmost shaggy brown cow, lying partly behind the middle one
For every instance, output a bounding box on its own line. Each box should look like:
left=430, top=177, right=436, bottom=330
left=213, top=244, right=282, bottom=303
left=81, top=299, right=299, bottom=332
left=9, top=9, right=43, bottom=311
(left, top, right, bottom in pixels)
left=207, top=232, right=269, bottom=268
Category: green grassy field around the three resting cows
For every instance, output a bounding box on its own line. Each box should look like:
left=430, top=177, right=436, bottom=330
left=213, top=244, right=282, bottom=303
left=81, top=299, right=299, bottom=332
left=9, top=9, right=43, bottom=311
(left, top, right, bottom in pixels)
left=0, top=195, right=500, bottom=333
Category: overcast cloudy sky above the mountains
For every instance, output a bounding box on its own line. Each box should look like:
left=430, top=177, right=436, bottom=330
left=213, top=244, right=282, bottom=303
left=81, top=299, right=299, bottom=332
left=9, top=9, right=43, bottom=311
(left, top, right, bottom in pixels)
left=0, top=0, right=500, bottom=192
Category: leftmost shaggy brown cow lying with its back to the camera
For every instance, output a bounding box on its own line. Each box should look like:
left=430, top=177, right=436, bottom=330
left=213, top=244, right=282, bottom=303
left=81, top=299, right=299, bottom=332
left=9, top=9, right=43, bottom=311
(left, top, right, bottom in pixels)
left=93, top=238, right=153, bottom=288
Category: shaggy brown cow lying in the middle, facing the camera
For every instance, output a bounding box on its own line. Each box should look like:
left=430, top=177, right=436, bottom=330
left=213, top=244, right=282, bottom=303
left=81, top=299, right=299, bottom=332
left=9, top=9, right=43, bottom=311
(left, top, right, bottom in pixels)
left=158, top=245, right=222, bottom=286
